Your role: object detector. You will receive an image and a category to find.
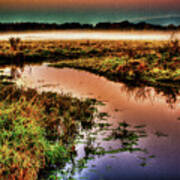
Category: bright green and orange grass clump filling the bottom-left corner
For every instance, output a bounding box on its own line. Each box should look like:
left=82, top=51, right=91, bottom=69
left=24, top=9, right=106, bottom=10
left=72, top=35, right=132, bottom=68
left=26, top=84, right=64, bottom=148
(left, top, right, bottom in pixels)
left=0, top=94, right=67, bottom=179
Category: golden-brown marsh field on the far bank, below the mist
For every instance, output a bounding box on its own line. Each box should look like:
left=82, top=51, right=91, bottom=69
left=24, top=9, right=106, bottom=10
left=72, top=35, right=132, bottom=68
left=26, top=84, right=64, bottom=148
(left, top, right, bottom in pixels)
left=0, top=39, right=180, bottom=86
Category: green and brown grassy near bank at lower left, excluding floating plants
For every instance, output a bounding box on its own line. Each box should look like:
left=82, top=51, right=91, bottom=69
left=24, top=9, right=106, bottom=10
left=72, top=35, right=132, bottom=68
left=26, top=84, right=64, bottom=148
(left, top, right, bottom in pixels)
left=0, top=85, right=95, bottom=180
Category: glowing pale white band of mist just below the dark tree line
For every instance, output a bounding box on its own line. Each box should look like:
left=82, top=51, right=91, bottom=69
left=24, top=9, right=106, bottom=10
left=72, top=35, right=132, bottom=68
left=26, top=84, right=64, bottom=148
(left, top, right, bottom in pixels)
left=0, top=30, right=180, bottom=41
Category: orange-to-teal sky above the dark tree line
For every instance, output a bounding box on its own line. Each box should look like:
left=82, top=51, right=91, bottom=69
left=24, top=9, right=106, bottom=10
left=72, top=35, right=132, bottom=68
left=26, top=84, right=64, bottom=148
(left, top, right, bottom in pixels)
left=0, top=0, right=180, bottom=25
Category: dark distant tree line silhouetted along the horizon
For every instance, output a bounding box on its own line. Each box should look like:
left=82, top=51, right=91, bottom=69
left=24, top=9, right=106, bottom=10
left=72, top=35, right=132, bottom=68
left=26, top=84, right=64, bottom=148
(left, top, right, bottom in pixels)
left=0, top=21, right=180, bottom=32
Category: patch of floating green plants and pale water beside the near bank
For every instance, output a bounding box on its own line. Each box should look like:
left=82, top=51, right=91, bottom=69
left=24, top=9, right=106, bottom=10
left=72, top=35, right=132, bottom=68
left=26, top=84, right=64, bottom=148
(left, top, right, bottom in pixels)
left=50, top=114, right=155, bottom=179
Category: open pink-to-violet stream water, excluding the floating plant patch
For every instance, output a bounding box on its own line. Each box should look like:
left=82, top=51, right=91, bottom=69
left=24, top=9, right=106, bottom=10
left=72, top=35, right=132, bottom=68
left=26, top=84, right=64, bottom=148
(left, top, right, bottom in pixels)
left=7, top=64, right=180, bottom=180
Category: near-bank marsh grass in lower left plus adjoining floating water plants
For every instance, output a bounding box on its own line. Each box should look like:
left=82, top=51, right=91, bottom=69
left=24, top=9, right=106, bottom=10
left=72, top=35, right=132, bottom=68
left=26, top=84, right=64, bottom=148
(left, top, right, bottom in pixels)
left=0, top=75, right=155, bottom=179
